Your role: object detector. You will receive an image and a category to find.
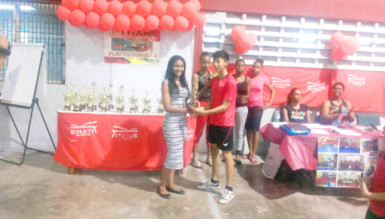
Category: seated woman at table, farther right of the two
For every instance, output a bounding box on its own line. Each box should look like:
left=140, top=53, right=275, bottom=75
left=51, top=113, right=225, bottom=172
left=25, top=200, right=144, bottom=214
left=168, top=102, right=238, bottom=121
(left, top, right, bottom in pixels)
left=320, top=82, right=356, bottom=126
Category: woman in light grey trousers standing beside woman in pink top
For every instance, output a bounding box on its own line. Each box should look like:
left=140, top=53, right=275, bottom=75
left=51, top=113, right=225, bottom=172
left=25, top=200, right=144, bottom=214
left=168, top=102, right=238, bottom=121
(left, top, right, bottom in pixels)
left=233, top=59, right=250, bottom=165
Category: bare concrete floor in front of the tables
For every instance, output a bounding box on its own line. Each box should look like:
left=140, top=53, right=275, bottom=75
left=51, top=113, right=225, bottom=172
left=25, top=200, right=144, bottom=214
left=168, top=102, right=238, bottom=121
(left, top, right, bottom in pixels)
left=0, top=152, right=368, bottom=219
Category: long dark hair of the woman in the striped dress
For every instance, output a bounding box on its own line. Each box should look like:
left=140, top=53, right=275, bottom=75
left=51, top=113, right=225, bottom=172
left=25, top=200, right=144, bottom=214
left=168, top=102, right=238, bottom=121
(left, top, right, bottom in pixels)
left=164, top=55, right=190, bottom=98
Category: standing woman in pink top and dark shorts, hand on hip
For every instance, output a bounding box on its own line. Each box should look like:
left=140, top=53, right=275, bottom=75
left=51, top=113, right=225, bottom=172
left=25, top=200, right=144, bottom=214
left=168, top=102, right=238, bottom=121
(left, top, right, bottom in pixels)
left=245, top=59, right=275, bottom=164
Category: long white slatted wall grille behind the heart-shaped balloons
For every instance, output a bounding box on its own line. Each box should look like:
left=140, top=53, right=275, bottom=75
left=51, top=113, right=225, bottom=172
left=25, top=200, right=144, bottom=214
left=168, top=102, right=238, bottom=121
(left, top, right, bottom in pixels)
left=202, top=12, right=385, bottom=71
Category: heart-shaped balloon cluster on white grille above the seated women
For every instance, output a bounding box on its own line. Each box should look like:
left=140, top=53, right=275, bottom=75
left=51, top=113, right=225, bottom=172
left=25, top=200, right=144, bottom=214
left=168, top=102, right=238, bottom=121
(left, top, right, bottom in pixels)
left=330, top=31, right=360, bottom=61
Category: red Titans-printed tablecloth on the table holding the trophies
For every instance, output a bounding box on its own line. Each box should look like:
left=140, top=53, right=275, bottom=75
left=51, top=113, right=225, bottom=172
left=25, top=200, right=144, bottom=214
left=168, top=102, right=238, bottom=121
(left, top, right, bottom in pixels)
left=54, top=112, right=195, bottom=170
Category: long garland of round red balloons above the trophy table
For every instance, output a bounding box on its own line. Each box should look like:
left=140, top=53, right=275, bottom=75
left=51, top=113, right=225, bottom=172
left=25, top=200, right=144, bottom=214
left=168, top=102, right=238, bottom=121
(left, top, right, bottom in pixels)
left=56, top=0, right=206, bottom=32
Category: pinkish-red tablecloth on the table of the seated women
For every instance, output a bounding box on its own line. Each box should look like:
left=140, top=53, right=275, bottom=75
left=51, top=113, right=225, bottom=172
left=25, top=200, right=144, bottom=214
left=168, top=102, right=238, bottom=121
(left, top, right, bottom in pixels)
left=260, top=123, right=380, bottom=170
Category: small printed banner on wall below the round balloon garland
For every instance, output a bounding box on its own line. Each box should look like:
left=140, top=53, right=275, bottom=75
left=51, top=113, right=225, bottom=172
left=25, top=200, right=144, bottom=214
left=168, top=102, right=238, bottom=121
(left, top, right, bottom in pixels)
left=104, top=31, right=160, bottom=64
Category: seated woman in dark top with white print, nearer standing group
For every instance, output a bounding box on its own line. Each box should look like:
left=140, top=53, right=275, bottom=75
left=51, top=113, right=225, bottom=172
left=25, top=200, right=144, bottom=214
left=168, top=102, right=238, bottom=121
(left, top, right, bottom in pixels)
left=282, top=88, right=311, bottom=123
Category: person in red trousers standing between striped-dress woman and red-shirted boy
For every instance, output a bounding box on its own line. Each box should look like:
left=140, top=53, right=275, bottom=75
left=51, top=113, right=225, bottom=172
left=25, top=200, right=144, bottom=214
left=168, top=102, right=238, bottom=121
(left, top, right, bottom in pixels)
left=191, top=52, right=212, bottom=168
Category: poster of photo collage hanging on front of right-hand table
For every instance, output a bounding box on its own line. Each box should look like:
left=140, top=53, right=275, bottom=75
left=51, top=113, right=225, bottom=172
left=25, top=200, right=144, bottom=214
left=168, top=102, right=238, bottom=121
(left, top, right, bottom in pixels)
left=315, top=137, right=382, bottom=188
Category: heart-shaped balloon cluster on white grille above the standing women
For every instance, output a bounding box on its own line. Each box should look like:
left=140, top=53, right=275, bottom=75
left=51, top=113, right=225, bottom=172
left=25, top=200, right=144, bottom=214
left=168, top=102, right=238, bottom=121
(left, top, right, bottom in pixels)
left=231, top=25, right=258, bottom=54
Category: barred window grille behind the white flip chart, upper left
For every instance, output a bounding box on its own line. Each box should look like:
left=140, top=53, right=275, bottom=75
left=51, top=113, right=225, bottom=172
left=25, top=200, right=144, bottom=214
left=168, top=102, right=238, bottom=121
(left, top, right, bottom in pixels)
left=0, top=1, right=65, bottom=84
